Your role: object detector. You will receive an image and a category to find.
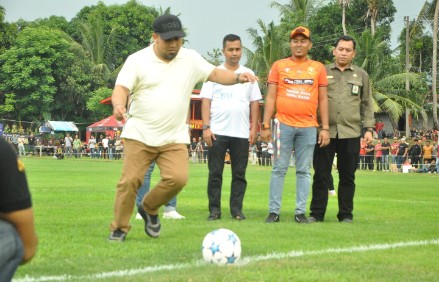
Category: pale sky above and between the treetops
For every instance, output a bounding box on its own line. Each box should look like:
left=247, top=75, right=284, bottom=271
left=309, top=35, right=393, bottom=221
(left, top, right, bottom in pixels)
left=0, top=0, right=425, bottom=56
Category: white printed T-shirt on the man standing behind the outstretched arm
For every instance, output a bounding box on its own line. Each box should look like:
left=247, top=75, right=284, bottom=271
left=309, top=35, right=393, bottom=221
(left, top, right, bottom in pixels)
left=200, top=65, right=262, bottom=138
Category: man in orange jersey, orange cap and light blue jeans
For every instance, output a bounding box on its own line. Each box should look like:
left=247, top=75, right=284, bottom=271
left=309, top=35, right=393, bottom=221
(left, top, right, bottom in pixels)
left=261, top=26, right=329, bottom=223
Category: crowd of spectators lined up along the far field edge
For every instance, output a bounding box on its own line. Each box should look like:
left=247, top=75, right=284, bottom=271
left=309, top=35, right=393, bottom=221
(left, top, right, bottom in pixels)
left=4, top=126, right=439, bottom=173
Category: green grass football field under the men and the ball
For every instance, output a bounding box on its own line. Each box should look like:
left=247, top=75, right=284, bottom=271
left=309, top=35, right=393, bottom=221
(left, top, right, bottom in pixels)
left=15, top=158, right=439, bottom=281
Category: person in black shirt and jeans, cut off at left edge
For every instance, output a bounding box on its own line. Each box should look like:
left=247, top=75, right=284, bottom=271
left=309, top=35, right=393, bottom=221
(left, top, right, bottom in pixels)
left=0, top=138, right=38, bottom=281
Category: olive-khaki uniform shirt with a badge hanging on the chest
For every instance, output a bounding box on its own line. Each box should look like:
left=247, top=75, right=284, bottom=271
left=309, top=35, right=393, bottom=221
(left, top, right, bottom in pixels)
left=326, top=63, right=375, bottom=139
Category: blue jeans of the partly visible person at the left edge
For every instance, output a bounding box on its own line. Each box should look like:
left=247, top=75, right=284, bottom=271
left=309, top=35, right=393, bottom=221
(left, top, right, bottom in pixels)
left=0, top=219, right=24, bottom=281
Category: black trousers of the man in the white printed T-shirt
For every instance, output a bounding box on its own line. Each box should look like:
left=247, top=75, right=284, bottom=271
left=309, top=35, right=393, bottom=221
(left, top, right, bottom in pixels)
left=207, top=135, right=249, bottom=216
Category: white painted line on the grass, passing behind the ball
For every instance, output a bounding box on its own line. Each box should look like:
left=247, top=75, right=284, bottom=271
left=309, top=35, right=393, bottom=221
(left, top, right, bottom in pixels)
left=13, top=239, right=439, bottom=282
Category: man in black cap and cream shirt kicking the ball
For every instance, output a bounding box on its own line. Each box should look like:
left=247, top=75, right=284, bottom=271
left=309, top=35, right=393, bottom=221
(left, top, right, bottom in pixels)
left=109, top=14, right=257, bottom=241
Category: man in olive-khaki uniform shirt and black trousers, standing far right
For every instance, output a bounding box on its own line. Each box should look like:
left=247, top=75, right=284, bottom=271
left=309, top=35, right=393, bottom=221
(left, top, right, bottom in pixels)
left=309, top=36, right=374, bottom=223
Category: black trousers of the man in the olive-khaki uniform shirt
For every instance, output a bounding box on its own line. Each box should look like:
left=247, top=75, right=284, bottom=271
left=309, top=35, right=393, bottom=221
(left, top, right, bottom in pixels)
left=310, top=137, right=360, bottom=220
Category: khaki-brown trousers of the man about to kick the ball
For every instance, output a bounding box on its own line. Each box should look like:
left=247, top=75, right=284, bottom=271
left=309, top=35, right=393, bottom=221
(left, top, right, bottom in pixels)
left=110, top=139, right=189, bottom=232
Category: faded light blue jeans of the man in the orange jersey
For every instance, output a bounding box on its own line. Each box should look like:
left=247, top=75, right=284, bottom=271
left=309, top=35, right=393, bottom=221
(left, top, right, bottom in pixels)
left=269, top=123, right=317, bottom=214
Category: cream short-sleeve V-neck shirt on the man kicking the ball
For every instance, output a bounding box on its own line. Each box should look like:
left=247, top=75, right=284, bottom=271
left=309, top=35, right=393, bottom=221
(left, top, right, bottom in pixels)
left=116, top=44, right=215, bottom=147
